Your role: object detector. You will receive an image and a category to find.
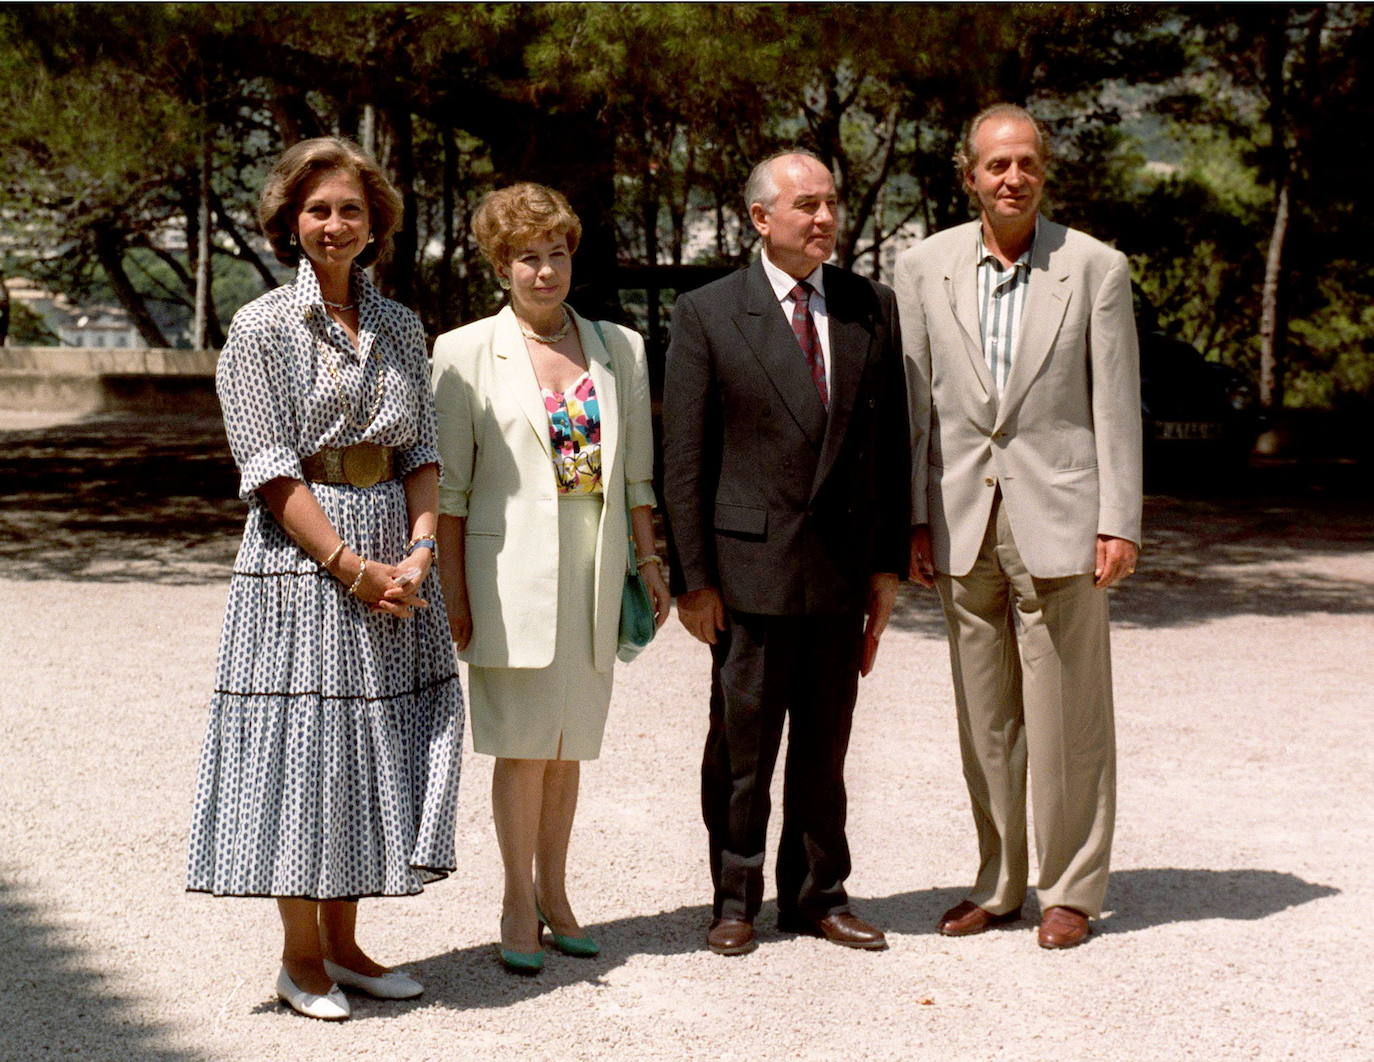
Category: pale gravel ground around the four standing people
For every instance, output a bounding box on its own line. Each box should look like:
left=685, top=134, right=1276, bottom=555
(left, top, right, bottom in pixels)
left=0, top=415, right=1374, bottom=1062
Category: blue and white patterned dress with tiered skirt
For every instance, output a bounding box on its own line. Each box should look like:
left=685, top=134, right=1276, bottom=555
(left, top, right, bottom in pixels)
left=187, top=261, right=463, bottom=900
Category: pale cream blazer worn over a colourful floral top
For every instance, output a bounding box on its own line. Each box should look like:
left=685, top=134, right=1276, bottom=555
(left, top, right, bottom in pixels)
left=433, top=306, right=654, bottom=670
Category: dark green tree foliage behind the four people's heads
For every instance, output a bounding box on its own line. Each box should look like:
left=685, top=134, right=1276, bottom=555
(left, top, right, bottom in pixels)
left=0, top=3, right=1374, bottom=414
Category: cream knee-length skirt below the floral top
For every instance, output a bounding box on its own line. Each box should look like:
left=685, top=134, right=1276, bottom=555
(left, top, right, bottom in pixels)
left=467, top=495, right=611, bottom=760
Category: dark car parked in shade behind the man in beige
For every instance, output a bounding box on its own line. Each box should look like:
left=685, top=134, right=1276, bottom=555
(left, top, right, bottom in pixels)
left=1135, top=289, right=1259, bottom=485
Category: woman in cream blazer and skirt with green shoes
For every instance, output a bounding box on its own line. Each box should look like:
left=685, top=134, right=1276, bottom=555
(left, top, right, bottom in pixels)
left=433, top=184, right=671, bottom=973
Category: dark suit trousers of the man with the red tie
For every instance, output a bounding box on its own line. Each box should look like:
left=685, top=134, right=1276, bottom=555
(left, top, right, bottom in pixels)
left=701, top=611, right=863, bottom=920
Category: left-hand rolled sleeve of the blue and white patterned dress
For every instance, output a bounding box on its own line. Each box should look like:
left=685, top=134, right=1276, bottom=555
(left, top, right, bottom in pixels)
left=214, top=313, right=304, bottom=501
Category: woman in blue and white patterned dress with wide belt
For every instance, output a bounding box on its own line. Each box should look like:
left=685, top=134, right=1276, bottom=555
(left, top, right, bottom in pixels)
left=187, top=137, right=463, bottom=1019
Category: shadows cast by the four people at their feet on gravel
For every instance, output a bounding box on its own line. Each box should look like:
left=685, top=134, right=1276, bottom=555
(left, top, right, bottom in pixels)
left=395, top=867, right=1340, bottom=1017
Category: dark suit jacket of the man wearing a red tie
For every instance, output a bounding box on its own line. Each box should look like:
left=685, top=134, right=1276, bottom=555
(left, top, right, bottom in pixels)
left=664, top=260, right=911, bottom=615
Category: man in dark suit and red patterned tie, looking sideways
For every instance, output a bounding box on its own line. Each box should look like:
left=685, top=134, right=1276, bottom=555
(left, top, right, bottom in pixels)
left=664, top=151, right=911, bottom=955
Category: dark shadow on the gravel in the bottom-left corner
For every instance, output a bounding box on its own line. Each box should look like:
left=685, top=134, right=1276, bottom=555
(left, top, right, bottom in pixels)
left=0, top=881, right=203, bottom=1062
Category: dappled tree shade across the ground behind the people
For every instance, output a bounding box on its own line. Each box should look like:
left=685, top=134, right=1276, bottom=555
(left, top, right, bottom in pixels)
left=8, top=414, right=1374, bottom=618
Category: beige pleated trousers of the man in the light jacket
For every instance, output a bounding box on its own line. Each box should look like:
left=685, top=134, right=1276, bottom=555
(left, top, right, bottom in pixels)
left=936, top=496, right=1116, bottom=918
